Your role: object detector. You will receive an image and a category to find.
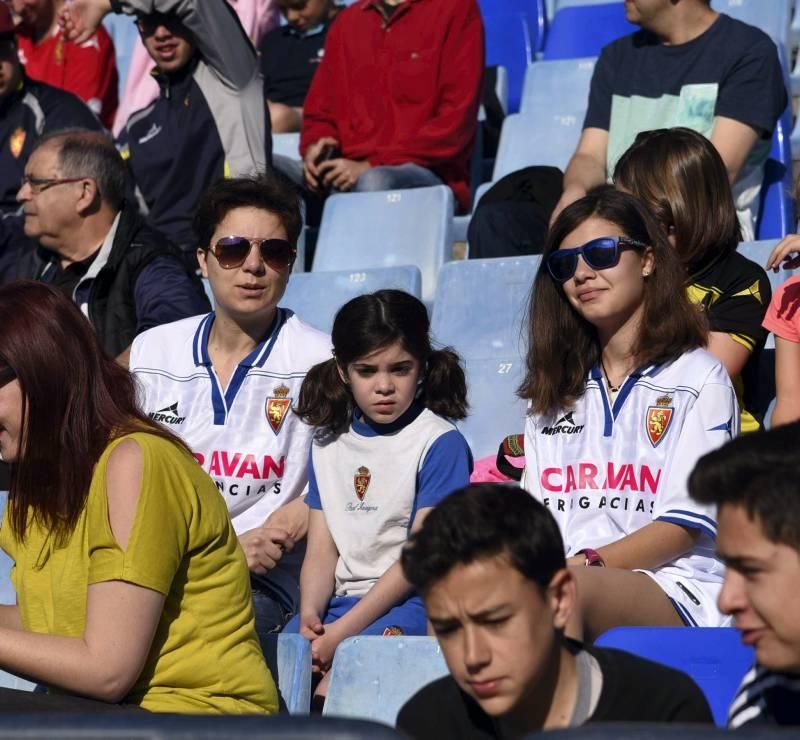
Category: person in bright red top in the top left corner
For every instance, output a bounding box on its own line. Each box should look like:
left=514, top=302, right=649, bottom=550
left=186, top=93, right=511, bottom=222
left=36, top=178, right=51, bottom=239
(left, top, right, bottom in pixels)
left=12, top=0, right=119, bottom=129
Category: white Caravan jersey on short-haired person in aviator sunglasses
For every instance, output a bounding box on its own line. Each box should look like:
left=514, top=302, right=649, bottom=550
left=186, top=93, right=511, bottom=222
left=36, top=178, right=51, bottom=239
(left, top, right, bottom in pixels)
left=130, top=308, right=331, bottom=534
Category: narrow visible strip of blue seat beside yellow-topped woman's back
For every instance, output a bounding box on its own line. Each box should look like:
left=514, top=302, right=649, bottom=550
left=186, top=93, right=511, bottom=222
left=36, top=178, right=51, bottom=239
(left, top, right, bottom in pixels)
left=261, top=634, right=311, bottom=714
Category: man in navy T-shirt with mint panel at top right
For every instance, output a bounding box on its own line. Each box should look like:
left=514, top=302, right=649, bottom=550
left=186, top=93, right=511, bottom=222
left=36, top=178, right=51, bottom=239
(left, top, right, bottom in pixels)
left=469, top=0, right=787, bottom=257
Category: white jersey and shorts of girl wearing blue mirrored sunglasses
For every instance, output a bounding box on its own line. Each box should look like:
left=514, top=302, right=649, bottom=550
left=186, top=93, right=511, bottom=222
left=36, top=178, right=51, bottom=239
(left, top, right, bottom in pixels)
left=524, top=349, right=739, bottom=584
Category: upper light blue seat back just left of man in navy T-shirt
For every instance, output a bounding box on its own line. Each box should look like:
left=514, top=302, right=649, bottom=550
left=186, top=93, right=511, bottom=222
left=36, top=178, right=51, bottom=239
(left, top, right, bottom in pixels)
left=520, top=57, right=597, bottom=117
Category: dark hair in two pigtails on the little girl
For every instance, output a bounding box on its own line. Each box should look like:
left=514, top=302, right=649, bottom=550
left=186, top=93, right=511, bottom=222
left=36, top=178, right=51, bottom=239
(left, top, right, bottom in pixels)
left=295, top=290, right=467, bottom=434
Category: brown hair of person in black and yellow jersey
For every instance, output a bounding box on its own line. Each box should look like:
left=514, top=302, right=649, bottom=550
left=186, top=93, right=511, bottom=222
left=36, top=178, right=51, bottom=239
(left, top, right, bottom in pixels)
left=614, top=128, right=742, bottom=273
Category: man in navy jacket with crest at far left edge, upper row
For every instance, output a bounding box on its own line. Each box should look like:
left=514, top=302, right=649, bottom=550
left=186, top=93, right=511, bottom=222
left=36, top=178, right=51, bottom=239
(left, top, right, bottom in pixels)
left=0, top=2, right=101, bottom=217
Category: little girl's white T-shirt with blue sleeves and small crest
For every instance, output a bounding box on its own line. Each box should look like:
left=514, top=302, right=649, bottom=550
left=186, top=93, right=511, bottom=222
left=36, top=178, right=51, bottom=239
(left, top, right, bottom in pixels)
left=306, top=403, right=472, bottom=596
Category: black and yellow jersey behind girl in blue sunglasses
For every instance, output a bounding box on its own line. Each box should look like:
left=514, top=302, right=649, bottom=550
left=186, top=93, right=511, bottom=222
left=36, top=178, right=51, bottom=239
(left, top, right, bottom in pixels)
left=687, top=252, right=772, bottom=432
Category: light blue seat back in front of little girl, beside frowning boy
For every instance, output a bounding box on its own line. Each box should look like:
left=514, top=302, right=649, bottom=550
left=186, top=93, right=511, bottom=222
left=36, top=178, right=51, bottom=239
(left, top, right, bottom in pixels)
left=323, top=637, right=447, bottom=725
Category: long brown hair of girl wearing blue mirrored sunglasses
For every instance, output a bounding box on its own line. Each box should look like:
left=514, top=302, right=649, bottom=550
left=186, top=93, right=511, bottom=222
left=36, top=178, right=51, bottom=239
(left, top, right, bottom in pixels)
left=518, top=186, right=707, bottom=414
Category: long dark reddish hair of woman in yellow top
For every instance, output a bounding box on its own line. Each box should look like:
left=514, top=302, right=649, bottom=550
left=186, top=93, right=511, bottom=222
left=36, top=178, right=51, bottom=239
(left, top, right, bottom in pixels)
left=0, top=281, right=186, bottom=541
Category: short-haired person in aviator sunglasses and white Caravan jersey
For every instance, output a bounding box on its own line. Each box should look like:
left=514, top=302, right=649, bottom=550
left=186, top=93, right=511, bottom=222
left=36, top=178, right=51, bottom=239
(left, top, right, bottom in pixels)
left=130, top=173, right=331, bottom=634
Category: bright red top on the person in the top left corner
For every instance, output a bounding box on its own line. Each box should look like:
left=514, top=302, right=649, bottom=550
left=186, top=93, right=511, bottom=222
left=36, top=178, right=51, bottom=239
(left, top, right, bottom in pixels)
left=17, top=26, right=118, bottom=130
